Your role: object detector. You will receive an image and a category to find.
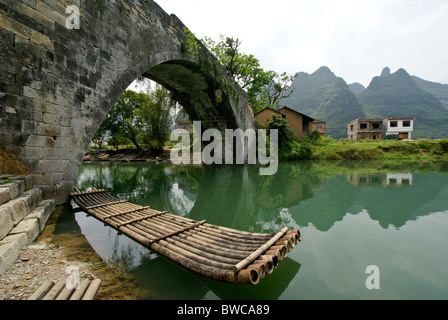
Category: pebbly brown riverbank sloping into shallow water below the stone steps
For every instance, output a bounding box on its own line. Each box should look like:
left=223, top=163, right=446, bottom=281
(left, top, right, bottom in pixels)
left=0, top=206, right=146, bottom=300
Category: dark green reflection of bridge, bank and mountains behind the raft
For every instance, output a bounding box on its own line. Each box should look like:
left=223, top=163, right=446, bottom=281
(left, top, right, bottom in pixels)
left=78, top=162, right=446, bottom=238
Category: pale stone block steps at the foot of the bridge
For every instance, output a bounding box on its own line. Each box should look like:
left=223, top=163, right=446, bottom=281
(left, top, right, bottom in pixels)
left=0, top=176, right=55, bottom=274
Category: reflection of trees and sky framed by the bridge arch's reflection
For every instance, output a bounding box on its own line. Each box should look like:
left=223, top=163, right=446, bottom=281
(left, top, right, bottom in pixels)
left=76, top=162, right=202, bottom=215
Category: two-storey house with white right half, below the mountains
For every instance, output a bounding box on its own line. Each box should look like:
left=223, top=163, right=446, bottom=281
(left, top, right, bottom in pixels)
left=347, top=117, right=414, bottom=141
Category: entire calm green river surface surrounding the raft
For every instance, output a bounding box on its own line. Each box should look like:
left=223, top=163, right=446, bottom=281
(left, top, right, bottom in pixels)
left=75, top=162, right=448, bottom=299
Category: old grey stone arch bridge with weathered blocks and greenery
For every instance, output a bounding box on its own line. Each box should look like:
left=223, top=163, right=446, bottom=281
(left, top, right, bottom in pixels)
left=0, top=0, right=254, bottom=203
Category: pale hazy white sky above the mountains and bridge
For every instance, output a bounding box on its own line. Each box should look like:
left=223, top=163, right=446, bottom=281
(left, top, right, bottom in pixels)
left=156, top=0, right=448, bottom=86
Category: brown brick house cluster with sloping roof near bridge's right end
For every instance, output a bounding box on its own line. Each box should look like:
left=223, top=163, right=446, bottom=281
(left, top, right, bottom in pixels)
left=255, top=107, right=326, bottom=139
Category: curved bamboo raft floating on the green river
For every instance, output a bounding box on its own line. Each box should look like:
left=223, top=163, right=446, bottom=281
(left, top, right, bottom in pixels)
left=71, top=188, right=302, bottom=285
